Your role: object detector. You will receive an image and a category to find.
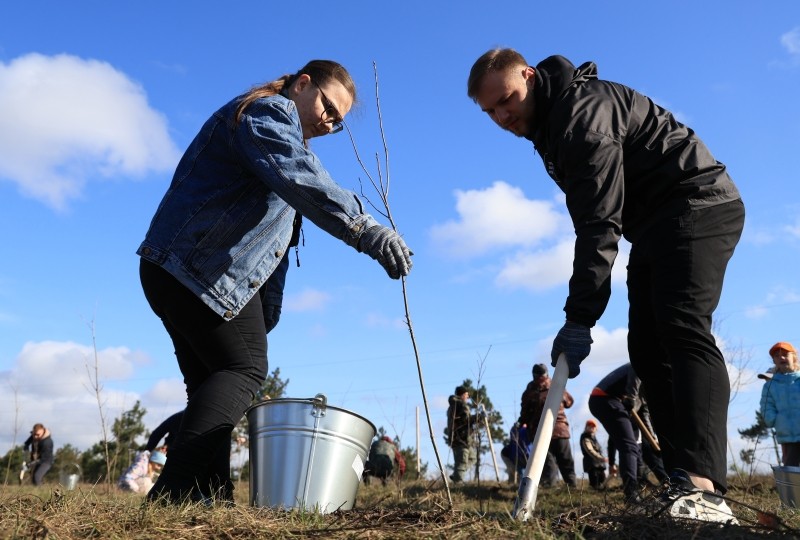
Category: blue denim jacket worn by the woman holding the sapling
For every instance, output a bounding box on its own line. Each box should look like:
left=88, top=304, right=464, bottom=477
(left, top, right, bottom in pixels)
left=136, top=95, right=377, bottom=320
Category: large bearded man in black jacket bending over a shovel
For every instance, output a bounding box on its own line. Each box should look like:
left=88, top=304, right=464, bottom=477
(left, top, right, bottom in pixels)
left=467, top=49, right=744, bottom=521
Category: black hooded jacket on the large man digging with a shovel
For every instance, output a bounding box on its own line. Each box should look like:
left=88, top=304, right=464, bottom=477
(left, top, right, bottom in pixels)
left=528, top=56, right=740, bottom=327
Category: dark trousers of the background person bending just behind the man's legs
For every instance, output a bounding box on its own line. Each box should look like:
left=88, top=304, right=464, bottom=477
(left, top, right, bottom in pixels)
left=589, top=396, right=642, bottom=497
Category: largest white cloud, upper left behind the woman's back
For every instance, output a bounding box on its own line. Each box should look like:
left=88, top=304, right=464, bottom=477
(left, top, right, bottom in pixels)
left=0, top=53, right=179, bottom=209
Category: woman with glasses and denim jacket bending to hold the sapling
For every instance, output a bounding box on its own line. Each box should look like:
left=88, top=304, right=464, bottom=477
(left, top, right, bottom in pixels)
left=137, top=60, right=411, bottom=503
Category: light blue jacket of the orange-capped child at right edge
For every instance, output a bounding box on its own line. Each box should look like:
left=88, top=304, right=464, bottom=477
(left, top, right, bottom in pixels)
left=761, top=371, right=800, bottom=443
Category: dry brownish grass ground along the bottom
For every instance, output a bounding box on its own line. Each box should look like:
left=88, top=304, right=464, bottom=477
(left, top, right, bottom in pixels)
left=0, top=477, right=800, bottom=540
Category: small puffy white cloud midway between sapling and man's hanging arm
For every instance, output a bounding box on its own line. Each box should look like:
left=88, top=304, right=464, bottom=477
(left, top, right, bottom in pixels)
left=431, top=182, right=570, bottom=258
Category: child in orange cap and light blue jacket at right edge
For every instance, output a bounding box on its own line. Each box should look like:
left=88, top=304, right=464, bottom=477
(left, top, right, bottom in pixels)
left=761, top=341, right=800, bottom=467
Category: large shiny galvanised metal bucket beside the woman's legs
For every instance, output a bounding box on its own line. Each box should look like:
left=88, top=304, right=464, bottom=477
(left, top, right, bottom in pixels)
left=245, top=394, right=376, bottom=514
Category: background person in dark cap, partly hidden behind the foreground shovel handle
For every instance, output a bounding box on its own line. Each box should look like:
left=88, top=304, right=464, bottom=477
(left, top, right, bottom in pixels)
left=517, top=364, right=578, bottom=487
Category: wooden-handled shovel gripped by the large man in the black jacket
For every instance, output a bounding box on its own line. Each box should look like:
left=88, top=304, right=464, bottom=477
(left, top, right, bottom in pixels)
left=511, top=353, right=569, bottom=521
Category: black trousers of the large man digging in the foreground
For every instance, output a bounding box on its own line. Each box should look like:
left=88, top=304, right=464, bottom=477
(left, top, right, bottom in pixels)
left=628, top=200, right=744, bottom=492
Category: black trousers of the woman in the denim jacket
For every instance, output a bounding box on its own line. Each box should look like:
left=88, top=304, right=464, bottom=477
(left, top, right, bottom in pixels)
left=139, top=260, right=267, bottom=500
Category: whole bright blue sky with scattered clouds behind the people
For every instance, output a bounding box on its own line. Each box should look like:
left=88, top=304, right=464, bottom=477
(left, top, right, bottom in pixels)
left=0, top=0, right=800, bottom=478
